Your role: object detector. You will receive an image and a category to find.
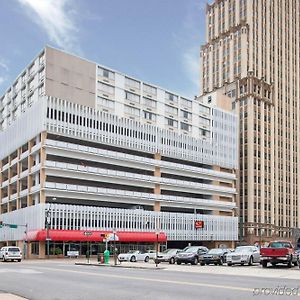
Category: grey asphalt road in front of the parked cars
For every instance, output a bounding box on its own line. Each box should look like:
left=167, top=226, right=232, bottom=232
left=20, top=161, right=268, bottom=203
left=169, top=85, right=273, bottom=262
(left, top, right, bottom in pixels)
left=0, top=261, right=300, bottom=300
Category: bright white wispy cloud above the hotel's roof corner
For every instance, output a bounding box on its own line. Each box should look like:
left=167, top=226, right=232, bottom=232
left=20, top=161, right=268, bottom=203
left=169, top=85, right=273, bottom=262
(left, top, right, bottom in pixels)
left=18, top=0, right=80, bottom=52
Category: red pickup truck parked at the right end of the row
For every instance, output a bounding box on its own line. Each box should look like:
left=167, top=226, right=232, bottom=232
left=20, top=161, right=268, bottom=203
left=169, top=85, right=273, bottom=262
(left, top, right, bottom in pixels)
left=260, top=241, right=298, bottom=268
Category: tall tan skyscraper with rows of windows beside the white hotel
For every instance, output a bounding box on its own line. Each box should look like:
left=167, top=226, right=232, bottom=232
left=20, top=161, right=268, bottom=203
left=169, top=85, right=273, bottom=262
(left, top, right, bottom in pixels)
left=200, top=0, right=300, bottom=242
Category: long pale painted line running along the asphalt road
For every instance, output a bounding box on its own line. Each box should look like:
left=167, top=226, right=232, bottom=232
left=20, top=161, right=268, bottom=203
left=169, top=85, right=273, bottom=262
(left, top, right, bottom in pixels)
left=31, top=267, right=253, bottom=292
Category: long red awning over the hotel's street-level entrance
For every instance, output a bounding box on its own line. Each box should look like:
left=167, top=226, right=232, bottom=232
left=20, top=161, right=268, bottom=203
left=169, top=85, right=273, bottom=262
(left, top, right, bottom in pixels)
left=25, top=229, right=167, bottom=243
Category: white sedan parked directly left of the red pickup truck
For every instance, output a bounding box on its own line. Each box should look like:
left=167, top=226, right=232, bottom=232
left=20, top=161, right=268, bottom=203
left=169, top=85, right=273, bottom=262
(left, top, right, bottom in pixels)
left=226, top=246, right=260, bottom=266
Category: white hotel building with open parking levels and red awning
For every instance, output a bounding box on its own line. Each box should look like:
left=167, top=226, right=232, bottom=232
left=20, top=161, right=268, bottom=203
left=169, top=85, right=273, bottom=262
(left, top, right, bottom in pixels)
left=0, top=47, right=238, bottom=257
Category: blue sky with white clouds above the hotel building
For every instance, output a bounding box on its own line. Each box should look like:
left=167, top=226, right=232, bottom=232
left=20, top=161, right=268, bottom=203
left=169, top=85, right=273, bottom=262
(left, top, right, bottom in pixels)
left=0, top=0, right=207, bottom=98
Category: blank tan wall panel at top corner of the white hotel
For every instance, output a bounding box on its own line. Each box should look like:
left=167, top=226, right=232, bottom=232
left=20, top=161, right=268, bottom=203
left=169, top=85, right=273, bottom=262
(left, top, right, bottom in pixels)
left=45, top=47, right=96, bottom=108
